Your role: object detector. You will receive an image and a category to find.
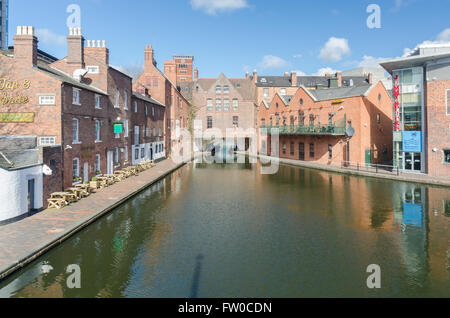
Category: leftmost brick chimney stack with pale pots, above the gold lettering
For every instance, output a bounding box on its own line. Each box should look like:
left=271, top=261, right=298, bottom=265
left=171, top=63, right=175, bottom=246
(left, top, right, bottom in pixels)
left=14, top=26, right=38, bottom=66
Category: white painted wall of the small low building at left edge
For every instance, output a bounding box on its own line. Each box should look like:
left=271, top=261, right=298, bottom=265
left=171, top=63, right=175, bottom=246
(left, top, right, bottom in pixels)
left=0, top=165, right=44, bottom=222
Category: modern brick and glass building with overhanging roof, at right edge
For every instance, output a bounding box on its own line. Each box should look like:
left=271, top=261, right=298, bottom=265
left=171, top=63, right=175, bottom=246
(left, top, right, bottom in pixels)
left=381, top=43, right=450, bottom=178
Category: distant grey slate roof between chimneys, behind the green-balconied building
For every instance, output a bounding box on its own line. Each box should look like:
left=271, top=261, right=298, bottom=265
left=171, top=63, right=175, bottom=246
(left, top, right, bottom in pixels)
left=256, top=76, right=368, bottom=87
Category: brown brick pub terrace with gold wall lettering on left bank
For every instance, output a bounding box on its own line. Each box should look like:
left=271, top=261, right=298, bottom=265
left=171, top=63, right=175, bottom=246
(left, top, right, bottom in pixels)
left=0, top=26, right=165, bottom=221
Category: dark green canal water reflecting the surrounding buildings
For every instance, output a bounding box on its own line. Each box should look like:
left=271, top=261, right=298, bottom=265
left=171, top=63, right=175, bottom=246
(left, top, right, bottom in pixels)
left=0, top=157, right=450, bottom=298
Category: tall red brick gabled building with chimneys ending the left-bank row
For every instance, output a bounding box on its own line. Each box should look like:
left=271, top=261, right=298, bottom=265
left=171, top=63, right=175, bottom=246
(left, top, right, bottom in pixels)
left=133, top=45, right=191, bottom=155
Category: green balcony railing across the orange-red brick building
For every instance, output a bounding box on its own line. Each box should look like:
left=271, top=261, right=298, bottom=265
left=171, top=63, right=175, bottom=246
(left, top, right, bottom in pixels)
left=261, top=124, right=346, bottom=136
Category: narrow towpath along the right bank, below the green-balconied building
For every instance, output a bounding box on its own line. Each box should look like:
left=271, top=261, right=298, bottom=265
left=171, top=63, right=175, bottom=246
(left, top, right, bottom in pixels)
left=251, top=155, right=450, bottom=187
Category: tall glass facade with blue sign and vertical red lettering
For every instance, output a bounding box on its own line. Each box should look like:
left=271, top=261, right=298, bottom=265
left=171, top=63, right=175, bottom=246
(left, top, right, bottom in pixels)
left=393, top=67, right=425, bottom=172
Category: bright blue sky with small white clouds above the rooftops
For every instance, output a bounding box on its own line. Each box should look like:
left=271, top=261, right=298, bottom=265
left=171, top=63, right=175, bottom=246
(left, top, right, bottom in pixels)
left=9, top=0, right=450, bottom=77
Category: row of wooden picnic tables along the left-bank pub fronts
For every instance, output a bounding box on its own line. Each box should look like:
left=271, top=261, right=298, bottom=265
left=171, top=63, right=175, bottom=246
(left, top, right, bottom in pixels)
left=47, top=160, right=156, bottom=209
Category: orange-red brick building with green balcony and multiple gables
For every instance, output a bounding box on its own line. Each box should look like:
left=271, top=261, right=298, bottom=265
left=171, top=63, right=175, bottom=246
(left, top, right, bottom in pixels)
left=258, top=82, right=392, bottom=166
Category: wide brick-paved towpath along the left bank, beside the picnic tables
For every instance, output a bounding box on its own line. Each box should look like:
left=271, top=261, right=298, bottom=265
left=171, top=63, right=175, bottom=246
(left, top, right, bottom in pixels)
left=0, top=159, right=187, bottom=280
